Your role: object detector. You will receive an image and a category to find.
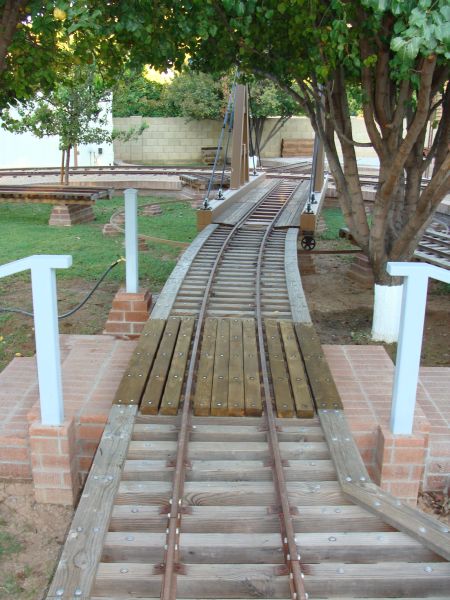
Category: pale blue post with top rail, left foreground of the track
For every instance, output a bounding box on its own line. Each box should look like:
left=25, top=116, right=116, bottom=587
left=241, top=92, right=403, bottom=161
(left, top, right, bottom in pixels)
left=0, top=255, right=72, bottom=425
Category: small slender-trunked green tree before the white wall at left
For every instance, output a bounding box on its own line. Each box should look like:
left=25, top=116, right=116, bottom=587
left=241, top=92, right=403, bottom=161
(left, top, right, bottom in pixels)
left=3, top=66, right=111, bottom=184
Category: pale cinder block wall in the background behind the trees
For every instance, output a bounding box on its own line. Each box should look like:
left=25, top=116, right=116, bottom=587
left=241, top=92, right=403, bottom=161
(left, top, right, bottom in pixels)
left=114, top=117, right=376, bottom=164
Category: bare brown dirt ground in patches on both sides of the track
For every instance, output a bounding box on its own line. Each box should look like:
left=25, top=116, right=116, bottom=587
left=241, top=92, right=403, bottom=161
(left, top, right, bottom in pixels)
left=0, top=243, right=450, bottom=600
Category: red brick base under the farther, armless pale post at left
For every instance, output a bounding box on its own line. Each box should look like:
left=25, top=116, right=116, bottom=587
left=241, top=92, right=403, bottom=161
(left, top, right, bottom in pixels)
left=103, top=288, right=152, bottom=339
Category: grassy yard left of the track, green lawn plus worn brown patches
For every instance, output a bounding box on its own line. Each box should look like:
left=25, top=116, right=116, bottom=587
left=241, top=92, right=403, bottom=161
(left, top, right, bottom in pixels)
left=0, top=197, right=197, bottom=371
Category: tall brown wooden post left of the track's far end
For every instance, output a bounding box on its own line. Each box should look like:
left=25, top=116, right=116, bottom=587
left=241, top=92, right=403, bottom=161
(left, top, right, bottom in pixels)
left=230, top=85, right=250, bottom=190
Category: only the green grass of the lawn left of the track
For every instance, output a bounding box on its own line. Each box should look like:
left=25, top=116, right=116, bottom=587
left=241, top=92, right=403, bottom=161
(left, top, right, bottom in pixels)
left=0, top=198, right=196, bottom=288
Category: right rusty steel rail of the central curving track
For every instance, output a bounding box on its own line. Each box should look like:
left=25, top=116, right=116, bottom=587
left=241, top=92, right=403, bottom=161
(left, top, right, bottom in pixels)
left=256, top=193, right=308, bottom=600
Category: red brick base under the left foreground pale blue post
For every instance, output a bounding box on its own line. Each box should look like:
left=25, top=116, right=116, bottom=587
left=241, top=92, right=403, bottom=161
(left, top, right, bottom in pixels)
left=29, top=419, right=80, bottom=506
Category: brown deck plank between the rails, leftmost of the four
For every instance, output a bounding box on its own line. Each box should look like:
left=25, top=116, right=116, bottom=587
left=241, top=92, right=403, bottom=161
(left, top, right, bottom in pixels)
left=194, top=318, right=217, bottom=416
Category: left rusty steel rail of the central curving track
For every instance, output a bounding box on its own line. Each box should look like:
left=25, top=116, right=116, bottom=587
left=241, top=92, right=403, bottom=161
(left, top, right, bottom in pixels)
left=161, top=183, right=295, bottom=600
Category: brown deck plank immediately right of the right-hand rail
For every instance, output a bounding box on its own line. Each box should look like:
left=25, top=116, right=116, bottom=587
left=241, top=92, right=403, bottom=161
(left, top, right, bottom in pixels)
left=265, top=319, right=295, bottom=417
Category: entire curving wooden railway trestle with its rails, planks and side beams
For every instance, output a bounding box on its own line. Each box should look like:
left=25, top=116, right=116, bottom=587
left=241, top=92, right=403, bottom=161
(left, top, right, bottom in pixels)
left=47, top=182, right=450, bottom=600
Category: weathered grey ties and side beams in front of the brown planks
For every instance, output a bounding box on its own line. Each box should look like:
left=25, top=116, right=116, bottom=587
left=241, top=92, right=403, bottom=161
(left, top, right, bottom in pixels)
left=47, top=406, right=450, bottom=600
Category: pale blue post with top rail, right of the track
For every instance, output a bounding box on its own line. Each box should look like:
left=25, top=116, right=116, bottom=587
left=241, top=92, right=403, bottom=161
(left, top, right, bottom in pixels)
left=386, top=263, right=450, bottom=435
